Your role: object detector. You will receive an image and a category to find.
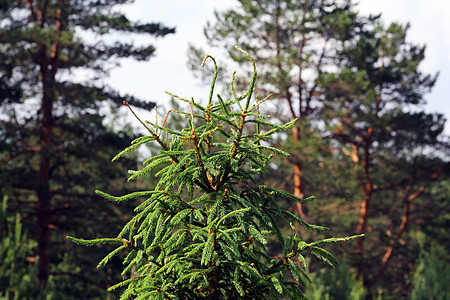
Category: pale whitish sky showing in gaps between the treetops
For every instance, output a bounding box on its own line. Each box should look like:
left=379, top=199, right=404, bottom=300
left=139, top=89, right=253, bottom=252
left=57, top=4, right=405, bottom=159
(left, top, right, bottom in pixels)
left=106, top=0, right=450, bottom=134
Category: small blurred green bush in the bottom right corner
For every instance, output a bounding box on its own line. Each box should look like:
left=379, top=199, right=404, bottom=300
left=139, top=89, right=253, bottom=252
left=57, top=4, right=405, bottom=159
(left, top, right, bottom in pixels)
left=411, top=245, right=450, bottom=300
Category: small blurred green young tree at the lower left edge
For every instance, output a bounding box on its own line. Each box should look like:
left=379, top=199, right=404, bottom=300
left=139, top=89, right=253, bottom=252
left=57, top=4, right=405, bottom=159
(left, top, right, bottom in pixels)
left=0, top=196, right=36, bottom=299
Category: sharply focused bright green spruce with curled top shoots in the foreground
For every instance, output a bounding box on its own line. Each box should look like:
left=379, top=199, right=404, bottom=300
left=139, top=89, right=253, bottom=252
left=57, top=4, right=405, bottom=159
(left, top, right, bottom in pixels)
left=68, top=48, right=359, bottom=299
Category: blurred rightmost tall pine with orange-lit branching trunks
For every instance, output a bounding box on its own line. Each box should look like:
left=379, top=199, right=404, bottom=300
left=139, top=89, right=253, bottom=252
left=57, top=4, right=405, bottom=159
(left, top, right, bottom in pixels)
left=321, top=16, right=450, bottom=296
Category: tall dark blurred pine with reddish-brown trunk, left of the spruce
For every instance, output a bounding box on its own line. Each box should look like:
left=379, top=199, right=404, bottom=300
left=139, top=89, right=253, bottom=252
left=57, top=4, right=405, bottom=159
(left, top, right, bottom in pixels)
left=0, top=0, right=175, bottom=299
